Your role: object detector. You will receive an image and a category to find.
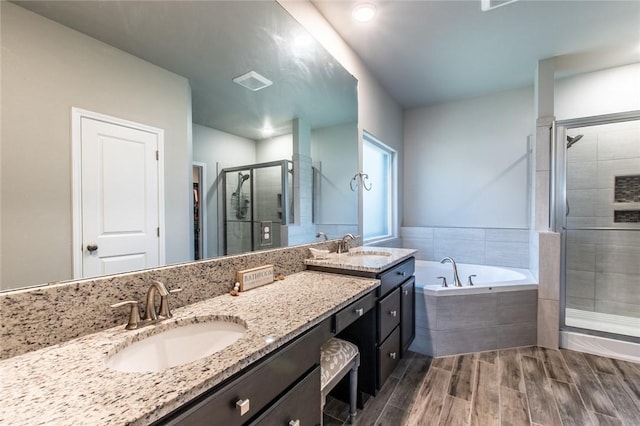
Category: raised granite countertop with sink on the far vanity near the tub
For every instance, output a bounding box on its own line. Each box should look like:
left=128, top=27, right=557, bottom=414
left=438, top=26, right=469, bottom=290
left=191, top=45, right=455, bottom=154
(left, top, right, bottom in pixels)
left=304, top=247, right=417, bottom=274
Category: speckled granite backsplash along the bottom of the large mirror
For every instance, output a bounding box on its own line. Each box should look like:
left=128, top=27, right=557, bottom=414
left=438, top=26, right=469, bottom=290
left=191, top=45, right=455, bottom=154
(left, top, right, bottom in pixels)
left=0, top=240, right=344, bottom=359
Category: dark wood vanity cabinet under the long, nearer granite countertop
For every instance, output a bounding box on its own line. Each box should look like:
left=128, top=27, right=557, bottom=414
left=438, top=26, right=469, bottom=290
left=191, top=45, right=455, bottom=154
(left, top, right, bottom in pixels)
left=154, top=290, right=380, bottom=426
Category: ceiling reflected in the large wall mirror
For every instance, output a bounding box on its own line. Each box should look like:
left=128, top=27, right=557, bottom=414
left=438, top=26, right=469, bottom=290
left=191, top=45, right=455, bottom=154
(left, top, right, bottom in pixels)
left=14, top=0, right=357, bottom=140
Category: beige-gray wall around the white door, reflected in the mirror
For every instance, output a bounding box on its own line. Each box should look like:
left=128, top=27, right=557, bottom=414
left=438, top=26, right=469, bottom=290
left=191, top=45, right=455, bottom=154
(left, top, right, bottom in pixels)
left=1, top=2, right=193, bottom=288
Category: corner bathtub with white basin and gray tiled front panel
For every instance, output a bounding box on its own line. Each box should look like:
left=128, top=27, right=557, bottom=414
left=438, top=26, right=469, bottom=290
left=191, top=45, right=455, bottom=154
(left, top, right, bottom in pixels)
left=410, top=261, right=538, bottom=357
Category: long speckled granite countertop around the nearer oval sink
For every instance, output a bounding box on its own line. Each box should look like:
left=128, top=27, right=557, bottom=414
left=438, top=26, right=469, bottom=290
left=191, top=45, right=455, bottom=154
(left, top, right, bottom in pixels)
left=0, top=271, right=379, bottom=425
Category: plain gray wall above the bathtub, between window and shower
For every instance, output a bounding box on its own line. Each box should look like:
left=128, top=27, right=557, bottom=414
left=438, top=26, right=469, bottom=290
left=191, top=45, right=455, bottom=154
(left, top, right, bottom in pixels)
left=403, top=87, right=533, bottom=228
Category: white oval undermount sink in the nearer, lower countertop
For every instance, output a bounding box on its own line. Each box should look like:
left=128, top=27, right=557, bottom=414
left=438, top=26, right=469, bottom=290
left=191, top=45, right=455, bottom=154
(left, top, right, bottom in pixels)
left=106, top=321, right=247, bottom=373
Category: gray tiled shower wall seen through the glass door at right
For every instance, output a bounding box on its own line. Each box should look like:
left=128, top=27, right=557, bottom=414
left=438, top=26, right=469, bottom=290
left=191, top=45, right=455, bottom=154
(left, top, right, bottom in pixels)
left=566, top=121, right=640, bottom=317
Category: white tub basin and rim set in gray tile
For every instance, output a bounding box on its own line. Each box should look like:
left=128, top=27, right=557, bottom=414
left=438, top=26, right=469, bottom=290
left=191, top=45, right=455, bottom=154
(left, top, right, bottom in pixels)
left=415, top=260, right=538, bottom=296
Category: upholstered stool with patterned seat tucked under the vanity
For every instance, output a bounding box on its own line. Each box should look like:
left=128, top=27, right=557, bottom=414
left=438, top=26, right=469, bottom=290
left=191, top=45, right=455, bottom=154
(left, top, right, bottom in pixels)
left=320, top=337, right=360, bottom=423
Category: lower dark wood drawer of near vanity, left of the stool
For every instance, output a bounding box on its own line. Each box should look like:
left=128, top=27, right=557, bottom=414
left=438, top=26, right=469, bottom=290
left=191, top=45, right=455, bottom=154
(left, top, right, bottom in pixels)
left=251, top=367, right=322, bottom=426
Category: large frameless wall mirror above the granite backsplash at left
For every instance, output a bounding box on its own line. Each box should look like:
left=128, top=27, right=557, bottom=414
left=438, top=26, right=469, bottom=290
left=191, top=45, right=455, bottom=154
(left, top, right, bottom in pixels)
left=0, top=1, right=358, bottom=290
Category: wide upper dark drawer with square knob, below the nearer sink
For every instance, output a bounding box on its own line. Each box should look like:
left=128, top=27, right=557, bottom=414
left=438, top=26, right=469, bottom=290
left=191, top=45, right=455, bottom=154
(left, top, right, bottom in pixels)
left=159, top=327, right=326, bottom=426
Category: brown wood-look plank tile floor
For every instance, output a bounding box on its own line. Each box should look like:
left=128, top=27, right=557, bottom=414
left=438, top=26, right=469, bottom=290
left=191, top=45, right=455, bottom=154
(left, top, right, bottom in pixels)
left=324, top=346, right=640, bottom=426
